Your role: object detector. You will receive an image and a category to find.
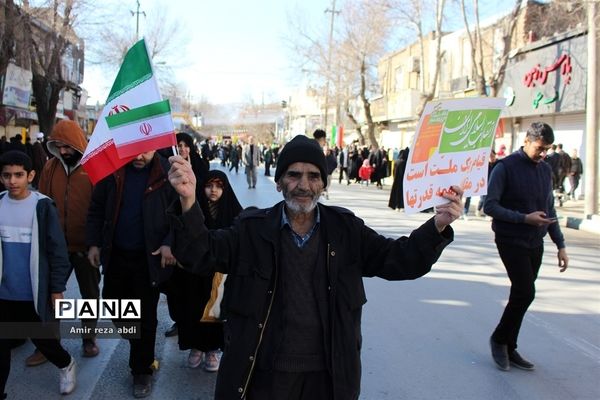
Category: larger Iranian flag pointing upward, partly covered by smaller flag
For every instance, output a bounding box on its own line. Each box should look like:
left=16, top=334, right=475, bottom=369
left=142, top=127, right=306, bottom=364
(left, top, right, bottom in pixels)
left=81, top=39, right=161, bottom=184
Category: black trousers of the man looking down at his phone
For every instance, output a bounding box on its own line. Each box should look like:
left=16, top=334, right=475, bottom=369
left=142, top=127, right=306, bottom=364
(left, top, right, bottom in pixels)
left=492, top=243, right=544, bottom=351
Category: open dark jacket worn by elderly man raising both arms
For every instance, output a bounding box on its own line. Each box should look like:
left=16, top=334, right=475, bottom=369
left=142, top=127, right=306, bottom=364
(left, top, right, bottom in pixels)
left=170, top=198, right=453, bottom=400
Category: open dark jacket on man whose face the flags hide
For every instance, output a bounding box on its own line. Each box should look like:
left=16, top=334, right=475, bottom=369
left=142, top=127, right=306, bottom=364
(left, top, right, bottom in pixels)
left=85, top=153, right=177, bottom=287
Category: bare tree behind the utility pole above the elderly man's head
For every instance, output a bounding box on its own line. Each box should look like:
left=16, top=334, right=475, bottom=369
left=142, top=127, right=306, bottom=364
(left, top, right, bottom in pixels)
left=290, top=0, right=392, bottom=147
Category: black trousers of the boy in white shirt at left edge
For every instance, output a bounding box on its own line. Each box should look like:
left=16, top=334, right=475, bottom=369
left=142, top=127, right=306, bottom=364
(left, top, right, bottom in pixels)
left=0, top=299, right=71, bottom=396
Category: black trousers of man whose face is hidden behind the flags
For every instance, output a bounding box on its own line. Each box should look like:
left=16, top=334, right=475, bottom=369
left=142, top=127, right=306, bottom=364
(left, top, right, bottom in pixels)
left=102, top=248, right=160, bottom=375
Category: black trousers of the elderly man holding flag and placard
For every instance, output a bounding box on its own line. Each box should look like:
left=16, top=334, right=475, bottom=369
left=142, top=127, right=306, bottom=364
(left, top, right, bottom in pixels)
left=246, top=371, right=333, bottom=400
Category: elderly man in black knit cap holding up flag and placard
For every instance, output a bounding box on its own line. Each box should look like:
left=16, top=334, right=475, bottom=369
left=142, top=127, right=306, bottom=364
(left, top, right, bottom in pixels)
left=169, top=136, right=461, bottom=400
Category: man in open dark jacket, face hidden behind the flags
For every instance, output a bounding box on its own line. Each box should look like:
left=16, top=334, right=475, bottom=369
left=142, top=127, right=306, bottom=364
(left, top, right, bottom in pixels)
left=86, top=151, right=176, bottom=397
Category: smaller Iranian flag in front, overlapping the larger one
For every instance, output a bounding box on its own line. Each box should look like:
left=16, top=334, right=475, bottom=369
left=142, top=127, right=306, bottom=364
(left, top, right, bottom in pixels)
left=106, top=100, right=177, bottom=159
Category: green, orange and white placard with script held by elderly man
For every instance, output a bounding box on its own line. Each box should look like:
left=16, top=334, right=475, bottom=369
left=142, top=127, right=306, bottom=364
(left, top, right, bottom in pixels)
left=403, top=98, right=505, bottom=214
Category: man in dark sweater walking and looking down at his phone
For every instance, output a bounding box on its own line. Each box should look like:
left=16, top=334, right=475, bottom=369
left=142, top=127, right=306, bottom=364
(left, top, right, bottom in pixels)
left=484, top=122, right=569, bottom=371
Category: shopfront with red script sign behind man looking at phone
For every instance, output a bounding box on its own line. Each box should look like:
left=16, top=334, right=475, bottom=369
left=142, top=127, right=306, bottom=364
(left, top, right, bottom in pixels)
left=496, top=28, right=593, bottom=197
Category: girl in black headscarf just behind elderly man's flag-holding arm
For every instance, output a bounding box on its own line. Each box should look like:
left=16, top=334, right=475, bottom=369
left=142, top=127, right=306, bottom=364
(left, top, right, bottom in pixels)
left=177, top=170, right=242, bottom=372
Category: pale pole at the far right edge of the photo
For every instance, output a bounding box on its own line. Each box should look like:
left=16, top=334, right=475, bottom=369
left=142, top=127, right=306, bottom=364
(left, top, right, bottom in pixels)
left=584, top=0, right=600, bottom=218
